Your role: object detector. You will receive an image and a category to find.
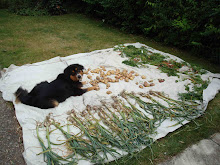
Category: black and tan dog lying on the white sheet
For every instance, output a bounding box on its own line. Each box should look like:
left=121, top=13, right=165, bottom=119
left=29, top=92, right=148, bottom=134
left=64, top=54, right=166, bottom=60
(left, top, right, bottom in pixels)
left=15, top=64, right=96, bottom=109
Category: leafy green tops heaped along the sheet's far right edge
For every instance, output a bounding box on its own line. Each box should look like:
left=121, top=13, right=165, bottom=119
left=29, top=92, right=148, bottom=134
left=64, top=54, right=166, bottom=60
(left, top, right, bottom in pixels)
left=114, top=45, right=209, bottom=101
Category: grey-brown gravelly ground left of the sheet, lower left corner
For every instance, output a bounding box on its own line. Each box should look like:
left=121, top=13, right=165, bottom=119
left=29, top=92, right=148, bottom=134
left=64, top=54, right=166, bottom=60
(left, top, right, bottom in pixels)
left=0, top=92, right=25, bottom=165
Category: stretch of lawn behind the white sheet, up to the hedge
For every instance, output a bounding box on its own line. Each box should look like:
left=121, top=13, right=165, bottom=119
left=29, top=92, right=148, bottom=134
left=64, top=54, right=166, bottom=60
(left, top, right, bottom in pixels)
left=0, top=10, right=220, bottom=72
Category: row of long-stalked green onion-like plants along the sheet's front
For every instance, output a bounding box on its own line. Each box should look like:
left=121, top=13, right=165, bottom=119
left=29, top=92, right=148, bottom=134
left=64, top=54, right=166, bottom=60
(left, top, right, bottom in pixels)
left=36, top=91, right=203, bottom=164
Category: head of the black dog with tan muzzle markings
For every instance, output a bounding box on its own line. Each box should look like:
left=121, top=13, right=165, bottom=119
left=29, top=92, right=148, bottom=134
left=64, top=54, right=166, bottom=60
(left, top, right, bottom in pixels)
left=64, top=64, right=84, bottom=81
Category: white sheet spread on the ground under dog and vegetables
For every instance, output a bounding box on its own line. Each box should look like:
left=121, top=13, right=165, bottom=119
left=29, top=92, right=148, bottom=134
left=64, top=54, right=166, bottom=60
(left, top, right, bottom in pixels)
left=0, top=43, right=220, bottom=165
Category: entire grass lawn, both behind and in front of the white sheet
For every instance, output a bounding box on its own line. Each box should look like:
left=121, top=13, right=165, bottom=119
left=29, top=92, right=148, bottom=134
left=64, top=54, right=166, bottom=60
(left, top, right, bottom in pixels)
left=0, top=10, right=220, bottom=165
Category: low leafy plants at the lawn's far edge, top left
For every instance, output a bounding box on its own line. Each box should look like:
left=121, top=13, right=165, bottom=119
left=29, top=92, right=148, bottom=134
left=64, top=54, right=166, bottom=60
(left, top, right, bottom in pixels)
left=9, top=0, right=66, bottom=16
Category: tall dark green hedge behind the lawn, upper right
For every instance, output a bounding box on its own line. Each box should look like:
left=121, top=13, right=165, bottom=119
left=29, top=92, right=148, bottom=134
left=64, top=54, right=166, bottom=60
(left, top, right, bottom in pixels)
left=67, top=0, right=220, bottom=62
